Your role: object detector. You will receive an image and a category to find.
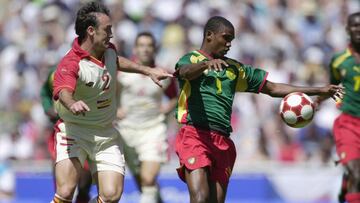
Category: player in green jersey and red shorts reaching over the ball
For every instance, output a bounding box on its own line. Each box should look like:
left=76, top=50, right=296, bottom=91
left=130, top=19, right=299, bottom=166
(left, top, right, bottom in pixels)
left=175, top=16, right=342, bottom=203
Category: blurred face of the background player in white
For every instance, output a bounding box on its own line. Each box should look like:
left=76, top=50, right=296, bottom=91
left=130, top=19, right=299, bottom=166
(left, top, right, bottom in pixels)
left=134, top=36, right=155, bottom=64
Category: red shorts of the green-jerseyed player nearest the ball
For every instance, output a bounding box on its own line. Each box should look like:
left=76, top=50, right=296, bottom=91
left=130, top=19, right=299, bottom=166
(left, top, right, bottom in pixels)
left=175, top=125, right=236, bottom=185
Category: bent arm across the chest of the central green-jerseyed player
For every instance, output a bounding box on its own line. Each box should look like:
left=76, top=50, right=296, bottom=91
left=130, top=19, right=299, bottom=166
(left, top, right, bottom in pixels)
left=178, top=59, right=228, bottom=80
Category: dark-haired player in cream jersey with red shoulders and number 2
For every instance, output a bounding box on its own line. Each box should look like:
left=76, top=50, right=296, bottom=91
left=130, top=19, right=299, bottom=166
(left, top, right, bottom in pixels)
left=53, top=1, right=172, bottom=203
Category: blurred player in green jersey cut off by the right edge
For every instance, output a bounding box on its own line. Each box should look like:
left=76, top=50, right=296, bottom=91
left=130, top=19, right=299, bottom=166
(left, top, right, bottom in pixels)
left=322, top=12, right=360, bottom=203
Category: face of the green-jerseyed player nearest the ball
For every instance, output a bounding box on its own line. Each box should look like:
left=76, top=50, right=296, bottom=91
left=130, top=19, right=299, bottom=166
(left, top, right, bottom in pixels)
left=212, top=26, right=234, bottom=58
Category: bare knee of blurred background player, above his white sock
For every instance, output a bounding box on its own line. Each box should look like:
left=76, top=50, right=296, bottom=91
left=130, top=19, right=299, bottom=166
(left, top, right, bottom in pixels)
left=140, top=161, right=161, bottom=185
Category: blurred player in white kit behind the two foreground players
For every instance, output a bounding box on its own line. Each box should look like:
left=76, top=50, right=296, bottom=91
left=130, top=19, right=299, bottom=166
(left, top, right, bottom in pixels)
left=117, top=32, right=177, bottom=203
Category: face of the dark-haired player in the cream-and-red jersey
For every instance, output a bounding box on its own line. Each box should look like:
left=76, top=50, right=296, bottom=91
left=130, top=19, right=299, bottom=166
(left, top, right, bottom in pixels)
left=93, top=13, right=113, bottom=50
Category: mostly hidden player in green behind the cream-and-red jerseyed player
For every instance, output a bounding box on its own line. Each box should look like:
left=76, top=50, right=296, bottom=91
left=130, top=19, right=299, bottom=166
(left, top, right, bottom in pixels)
left=40, top=66, right=92, bottom=203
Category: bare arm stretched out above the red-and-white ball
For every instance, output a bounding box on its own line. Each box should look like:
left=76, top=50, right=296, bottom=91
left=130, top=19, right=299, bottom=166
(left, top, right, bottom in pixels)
left=261, top=81, right=344, bottom=99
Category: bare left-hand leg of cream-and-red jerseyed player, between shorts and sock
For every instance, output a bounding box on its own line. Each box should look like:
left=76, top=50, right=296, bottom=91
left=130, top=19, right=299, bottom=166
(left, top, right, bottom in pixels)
left=55, top=157, right=82, bottom=190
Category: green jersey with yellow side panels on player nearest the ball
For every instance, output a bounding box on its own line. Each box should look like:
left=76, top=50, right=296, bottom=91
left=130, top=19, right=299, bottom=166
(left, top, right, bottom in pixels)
left=175, top=51, right=267, bottom=136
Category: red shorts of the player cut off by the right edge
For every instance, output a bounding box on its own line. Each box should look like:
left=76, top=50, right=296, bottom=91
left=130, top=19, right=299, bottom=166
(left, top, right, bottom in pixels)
left=334, top=113, right=360, bottom=164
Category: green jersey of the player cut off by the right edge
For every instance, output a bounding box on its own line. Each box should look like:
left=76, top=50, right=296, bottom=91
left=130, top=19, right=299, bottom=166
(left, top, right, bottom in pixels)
left=330, top=48, right=360, bottom=117
